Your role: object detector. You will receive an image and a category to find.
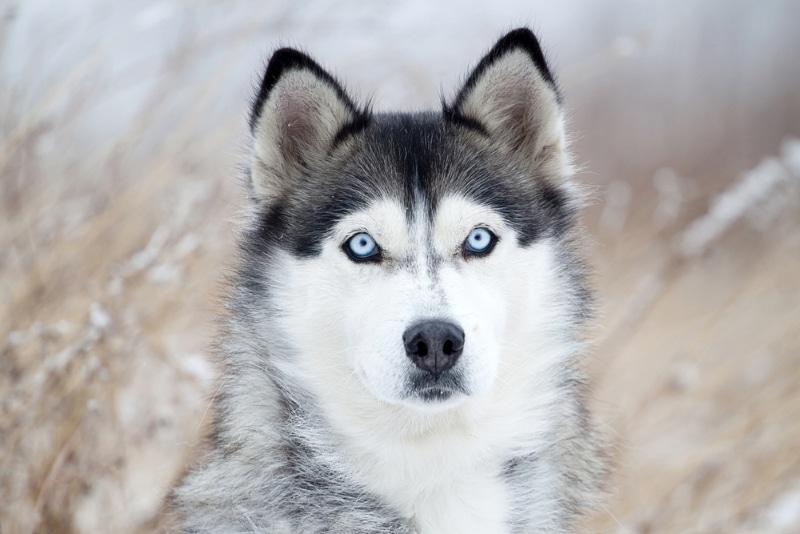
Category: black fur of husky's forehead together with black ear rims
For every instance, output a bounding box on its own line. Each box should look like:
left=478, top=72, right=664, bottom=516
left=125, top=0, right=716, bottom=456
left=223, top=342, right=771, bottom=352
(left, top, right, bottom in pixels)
left=249, top=28, right=575, bottom=257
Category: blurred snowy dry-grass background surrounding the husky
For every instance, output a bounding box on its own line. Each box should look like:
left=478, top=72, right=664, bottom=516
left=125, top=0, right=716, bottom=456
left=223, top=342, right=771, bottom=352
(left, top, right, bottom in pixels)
left=0, top=0, right=800, bottom=534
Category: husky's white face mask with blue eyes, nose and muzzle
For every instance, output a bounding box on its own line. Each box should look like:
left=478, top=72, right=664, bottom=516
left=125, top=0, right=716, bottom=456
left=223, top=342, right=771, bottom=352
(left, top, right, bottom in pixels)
left=280, top=195, right=558, bottom=410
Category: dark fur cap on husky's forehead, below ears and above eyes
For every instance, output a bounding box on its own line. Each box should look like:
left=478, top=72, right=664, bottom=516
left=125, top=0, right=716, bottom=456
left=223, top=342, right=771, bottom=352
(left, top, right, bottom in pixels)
left=250, top=114, right=575, bottom=257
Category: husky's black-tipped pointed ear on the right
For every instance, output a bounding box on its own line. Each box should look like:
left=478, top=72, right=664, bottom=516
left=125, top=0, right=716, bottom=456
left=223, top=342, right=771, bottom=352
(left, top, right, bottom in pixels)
left=444, top=28, right=566, bottom=174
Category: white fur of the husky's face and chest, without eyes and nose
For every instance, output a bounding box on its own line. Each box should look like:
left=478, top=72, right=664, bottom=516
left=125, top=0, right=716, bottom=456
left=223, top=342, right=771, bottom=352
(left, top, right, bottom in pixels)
left=262, top=196, right=574, bottom=534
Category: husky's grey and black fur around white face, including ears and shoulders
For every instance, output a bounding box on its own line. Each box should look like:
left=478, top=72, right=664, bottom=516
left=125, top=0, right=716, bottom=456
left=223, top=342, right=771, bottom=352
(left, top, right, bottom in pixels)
left=174, top=30, right=605, bottom=534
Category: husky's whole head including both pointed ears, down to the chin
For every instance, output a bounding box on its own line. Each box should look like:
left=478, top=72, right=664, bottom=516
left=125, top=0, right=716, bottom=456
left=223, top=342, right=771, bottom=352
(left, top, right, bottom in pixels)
left=246, top=31, right=577, bottom=411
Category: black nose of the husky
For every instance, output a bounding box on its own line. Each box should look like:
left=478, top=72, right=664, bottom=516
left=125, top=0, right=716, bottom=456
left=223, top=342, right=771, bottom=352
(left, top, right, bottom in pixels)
left=403, top=321, right=464, bottom=378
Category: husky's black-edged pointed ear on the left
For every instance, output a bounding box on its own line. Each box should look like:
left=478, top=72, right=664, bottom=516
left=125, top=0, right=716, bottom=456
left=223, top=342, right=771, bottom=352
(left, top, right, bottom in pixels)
left=250, top=48, right=369, bottom=200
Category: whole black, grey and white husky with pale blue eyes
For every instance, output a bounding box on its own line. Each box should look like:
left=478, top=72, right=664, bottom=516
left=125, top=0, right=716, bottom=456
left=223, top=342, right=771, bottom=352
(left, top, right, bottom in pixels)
left=174, top=29, right=605, bottom=534
